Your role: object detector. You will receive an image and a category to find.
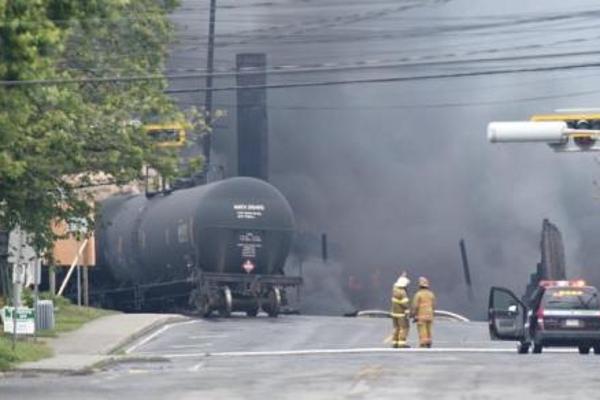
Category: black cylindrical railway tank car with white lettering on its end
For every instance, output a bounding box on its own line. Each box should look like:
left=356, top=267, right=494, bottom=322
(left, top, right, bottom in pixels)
left=90, top=177, right=302, bottom=317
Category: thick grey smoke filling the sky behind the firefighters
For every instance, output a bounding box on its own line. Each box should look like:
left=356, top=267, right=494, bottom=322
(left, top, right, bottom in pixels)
left=168, top=0, right=600, bottom=316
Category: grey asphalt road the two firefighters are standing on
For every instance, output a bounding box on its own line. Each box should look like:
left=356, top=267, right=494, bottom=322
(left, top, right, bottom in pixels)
left=0, top=316, right=600, bottom=400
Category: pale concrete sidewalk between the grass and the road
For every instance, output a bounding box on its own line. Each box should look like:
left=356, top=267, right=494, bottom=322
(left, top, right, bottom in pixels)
left=16, top=314, right=187, bottom=374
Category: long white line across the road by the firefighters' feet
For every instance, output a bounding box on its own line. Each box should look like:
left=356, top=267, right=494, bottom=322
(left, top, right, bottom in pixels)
left=140, top=347, right=576, bottom=358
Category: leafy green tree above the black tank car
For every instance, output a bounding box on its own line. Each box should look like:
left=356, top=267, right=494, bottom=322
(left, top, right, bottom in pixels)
left=0, top=0, right=184, bottom=250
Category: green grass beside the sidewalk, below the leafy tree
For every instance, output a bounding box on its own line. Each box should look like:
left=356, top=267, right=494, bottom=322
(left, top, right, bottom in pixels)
left=0, top=297, right=115, bottom=371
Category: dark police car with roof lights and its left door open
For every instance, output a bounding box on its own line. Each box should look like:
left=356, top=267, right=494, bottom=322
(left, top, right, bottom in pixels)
left=488, top=280, right=600, bottom=354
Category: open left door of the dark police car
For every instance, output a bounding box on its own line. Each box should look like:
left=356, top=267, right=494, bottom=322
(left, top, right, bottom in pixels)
left=488, top=287, right=527, bottom=340
